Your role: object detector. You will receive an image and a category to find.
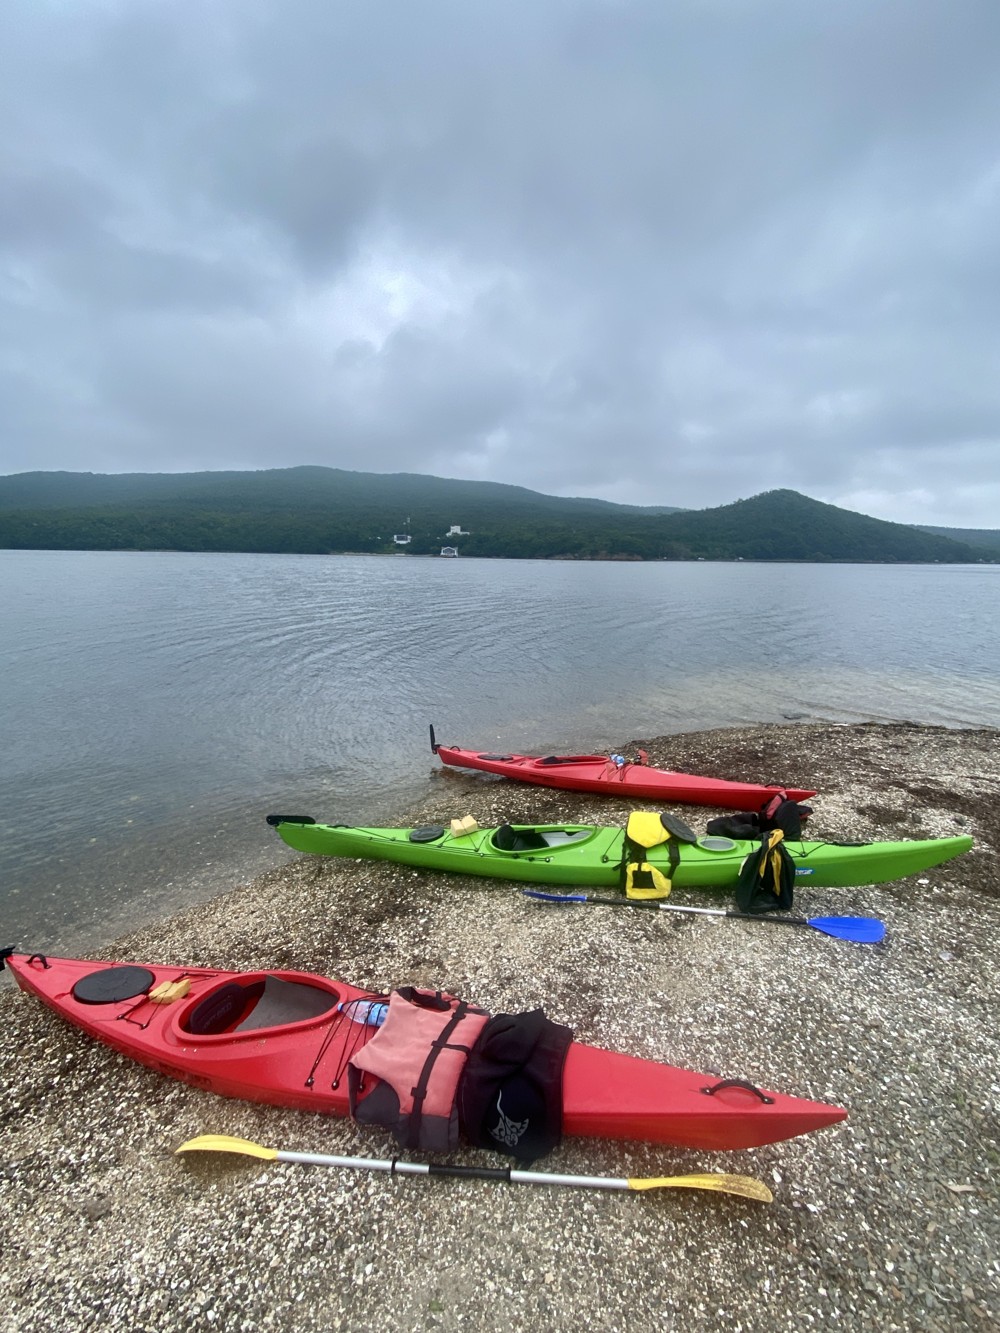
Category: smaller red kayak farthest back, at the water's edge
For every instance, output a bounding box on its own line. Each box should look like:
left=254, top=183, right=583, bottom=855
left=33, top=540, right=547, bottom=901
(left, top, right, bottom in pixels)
left=431, top=726, right=816, bottom=810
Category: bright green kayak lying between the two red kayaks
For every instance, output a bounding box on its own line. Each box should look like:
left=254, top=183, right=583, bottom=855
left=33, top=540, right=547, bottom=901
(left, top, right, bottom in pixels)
left=267, top=814, right=972, bottom=889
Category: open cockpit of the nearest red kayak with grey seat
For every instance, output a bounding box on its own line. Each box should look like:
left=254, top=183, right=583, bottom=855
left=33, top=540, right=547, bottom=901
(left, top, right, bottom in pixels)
left=184, top=973, right=340, bottom=1037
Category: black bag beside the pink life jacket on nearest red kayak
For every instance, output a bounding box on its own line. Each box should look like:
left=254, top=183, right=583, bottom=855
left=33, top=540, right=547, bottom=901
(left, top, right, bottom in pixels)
left=456, top=1009, right=573, bottom=1162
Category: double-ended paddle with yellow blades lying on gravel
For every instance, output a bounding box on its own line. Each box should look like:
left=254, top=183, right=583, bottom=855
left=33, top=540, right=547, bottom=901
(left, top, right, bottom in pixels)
left=176, top=1134, right=773, bottom=1204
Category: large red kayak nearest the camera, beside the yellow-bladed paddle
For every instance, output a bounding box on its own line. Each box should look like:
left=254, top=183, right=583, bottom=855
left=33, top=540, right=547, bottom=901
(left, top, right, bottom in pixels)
left=3, top=953, right=847, bottom=1149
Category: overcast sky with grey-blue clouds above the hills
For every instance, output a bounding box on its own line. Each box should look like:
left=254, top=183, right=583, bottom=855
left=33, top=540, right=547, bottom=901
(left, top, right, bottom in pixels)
left=0, top=0, right=1000, bottom=528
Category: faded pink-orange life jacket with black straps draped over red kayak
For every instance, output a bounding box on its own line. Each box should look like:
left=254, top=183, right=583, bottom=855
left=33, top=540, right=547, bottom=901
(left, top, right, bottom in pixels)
left=348, top=986, right=489, bottom=1152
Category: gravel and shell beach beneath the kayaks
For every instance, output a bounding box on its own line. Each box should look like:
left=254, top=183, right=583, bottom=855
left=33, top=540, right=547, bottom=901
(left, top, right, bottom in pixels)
left=0, top=724, right=1000, bottom=1333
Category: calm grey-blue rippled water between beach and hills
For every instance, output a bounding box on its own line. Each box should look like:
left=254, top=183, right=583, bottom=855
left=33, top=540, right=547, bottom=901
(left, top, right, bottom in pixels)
left=0, top=551, right=1000, bottom=949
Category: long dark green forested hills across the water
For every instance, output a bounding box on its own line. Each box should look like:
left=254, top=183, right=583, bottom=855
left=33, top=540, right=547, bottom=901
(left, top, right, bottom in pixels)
left=0, top=467, right=1000, bottom=564
